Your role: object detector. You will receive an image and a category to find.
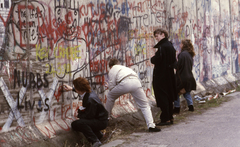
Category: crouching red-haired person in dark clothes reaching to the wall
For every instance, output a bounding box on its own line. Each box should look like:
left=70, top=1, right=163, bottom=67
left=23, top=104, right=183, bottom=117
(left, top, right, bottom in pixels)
left=64, top=77, right=108, bottom=147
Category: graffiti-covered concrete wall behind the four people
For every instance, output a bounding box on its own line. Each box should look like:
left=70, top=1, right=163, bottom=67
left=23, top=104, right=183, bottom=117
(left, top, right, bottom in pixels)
left=0, top=0, right=240, bottom=144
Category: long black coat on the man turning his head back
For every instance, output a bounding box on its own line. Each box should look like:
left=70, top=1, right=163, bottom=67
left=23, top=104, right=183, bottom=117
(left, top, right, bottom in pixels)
left=151, top=38, right=177, bottom=106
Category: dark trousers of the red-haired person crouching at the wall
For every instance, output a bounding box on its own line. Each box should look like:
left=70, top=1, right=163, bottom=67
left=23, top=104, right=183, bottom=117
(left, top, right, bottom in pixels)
left=71, top=119, right=108, bottom=143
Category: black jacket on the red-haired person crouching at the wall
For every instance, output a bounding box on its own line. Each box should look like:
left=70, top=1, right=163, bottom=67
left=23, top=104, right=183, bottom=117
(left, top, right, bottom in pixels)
left=78, top=92, right=108, bottom=120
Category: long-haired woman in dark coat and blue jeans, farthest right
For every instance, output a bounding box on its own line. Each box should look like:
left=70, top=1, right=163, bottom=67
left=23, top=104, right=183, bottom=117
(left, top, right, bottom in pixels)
left=173, top=39, right=196, bottom=113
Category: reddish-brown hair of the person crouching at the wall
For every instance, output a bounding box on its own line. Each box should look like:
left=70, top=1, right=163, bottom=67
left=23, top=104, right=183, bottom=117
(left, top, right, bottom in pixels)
left=73, top=77, right=91, bottom=93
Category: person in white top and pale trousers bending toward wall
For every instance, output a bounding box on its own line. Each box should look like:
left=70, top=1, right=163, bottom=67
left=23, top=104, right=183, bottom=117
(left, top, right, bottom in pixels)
left=106, top=58, right=161, bottom=132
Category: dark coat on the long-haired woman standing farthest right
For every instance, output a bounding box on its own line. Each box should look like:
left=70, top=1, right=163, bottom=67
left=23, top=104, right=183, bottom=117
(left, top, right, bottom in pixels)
left=176, top=50, right=196, bottom=92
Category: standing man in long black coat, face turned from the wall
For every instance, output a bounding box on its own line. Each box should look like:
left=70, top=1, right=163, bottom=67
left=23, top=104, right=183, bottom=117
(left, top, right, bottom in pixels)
left=151, top=29, right=177, bottom=126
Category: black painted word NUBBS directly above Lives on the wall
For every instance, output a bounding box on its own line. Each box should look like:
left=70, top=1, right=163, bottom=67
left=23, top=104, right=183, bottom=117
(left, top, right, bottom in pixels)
left=14, top=69, right=49, bottom=89
